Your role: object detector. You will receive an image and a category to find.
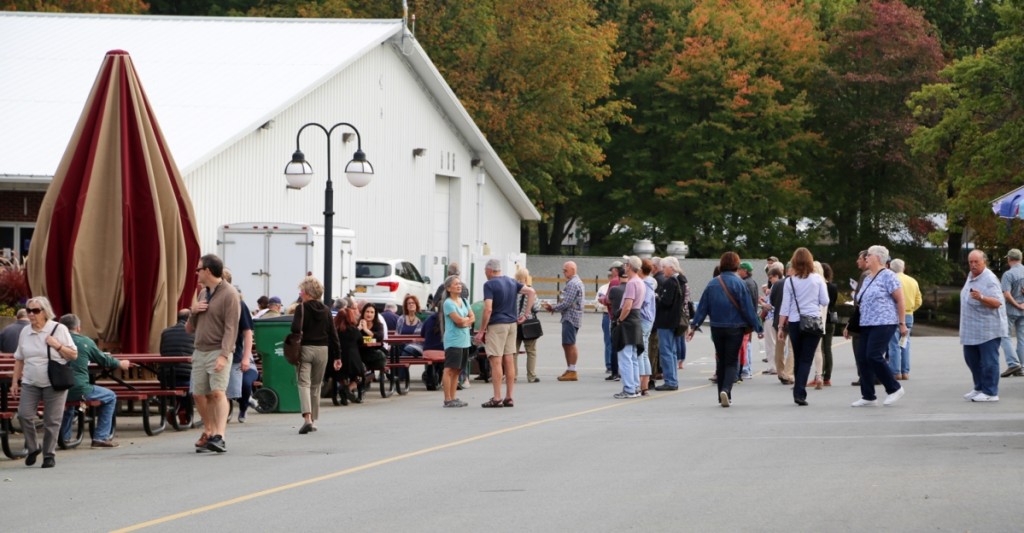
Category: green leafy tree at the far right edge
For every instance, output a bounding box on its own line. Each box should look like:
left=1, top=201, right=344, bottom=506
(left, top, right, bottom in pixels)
left=910, top=2, right=1024, bottom=250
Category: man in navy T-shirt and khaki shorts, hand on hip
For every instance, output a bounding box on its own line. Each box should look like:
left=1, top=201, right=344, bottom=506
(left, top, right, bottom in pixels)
left=476, top=259, right=537, bottom=407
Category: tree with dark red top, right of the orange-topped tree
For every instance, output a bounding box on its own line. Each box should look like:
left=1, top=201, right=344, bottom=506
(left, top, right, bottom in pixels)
left=812, top=0, right=943, bottom=250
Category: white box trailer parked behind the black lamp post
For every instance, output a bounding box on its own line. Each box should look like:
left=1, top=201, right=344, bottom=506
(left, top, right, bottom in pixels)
left=217, top=222, right=355, bottom=302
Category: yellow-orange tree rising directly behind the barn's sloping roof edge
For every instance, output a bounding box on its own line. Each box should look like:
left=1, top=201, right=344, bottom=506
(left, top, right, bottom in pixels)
left=417, top=0, right=626, bottom=253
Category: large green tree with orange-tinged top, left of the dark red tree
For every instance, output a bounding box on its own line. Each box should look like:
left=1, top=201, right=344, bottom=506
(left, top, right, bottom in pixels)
left=590, top=0, right=821, bottom=255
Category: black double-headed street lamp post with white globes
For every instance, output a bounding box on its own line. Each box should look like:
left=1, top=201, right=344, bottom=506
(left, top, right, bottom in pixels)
left=285, top=122, right=374, bottom=307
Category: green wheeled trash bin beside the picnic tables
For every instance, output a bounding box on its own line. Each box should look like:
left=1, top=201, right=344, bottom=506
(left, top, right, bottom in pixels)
left=253, top=315, right=301, bottom=412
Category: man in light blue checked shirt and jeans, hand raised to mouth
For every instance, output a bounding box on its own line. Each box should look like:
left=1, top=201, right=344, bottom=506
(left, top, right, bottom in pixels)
left=959, top=250, right=1008, bottom=402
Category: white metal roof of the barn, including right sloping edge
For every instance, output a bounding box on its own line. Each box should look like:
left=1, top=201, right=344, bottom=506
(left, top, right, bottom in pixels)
left=0, top=11, right=540, bottom=220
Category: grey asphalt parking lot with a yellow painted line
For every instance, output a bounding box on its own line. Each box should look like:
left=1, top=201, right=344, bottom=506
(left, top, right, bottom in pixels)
left=0, top=308, right=1024, bottom=532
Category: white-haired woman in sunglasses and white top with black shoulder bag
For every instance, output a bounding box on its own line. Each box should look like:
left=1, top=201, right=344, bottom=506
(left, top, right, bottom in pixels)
left=10, top=297, right=78, bottom=469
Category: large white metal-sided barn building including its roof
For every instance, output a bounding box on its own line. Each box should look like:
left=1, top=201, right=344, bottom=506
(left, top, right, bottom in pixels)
left=0, top=12, right=540, bottom=296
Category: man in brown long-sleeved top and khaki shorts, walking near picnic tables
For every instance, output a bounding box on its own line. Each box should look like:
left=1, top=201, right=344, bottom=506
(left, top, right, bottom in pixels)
left=185, top=254, right=242, bottom=453
